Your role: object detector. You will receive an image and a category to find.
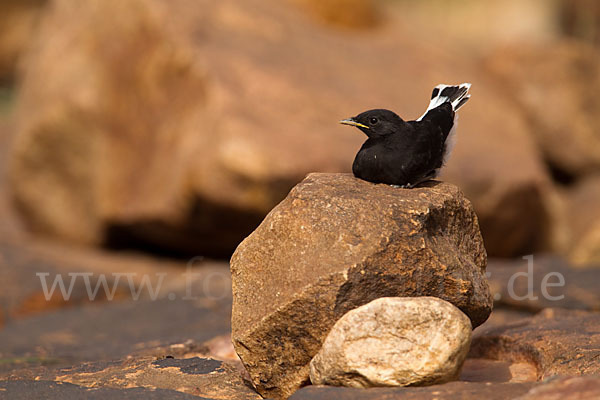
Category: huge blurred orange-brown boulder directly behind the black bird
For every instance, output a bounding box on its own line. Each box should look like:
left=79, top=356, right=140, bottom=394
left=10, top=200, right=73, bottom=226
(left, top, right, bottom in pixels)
left=11, top=0, right=549, bottom=255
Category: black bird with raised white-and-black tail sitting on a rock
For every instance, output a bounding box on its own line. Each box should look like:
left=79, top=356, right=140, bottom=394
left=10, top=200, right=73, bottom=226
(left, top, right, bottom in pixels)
left=340, top=83, right=471, bottom=188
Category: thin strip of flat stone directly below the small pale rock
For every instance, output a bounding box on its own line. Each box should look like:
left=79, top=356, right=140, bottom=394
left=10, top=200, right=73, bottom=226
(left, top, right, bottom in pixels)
left=290, top=382, right=534, bottom=400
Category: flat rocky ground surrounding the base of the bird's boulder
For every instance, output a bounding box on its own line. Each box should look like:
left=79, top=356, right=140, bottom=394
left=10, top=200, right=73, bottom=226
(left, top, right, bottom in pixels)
left=0, top=173, right=600, bottom=399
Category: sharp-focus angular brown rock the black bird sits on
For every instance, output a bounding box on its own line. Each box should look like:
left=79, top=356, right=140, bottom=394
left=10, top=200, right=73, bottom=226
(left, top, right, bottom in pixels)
left=231, top=174, right=492, bottom=398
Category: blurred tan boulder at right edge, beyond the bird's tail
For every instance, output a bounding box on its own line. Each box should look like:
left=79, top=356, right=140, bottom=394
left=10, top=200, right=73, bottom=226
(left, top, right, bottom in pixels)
left=488, top=41, right=600, bottom=176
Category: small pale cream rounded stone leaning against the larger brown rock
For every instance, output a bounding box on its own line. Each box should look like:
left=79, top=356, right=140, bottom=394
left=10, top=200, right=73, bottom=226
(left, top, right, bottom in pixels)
left=310, top=297, right=472, bottom=387
